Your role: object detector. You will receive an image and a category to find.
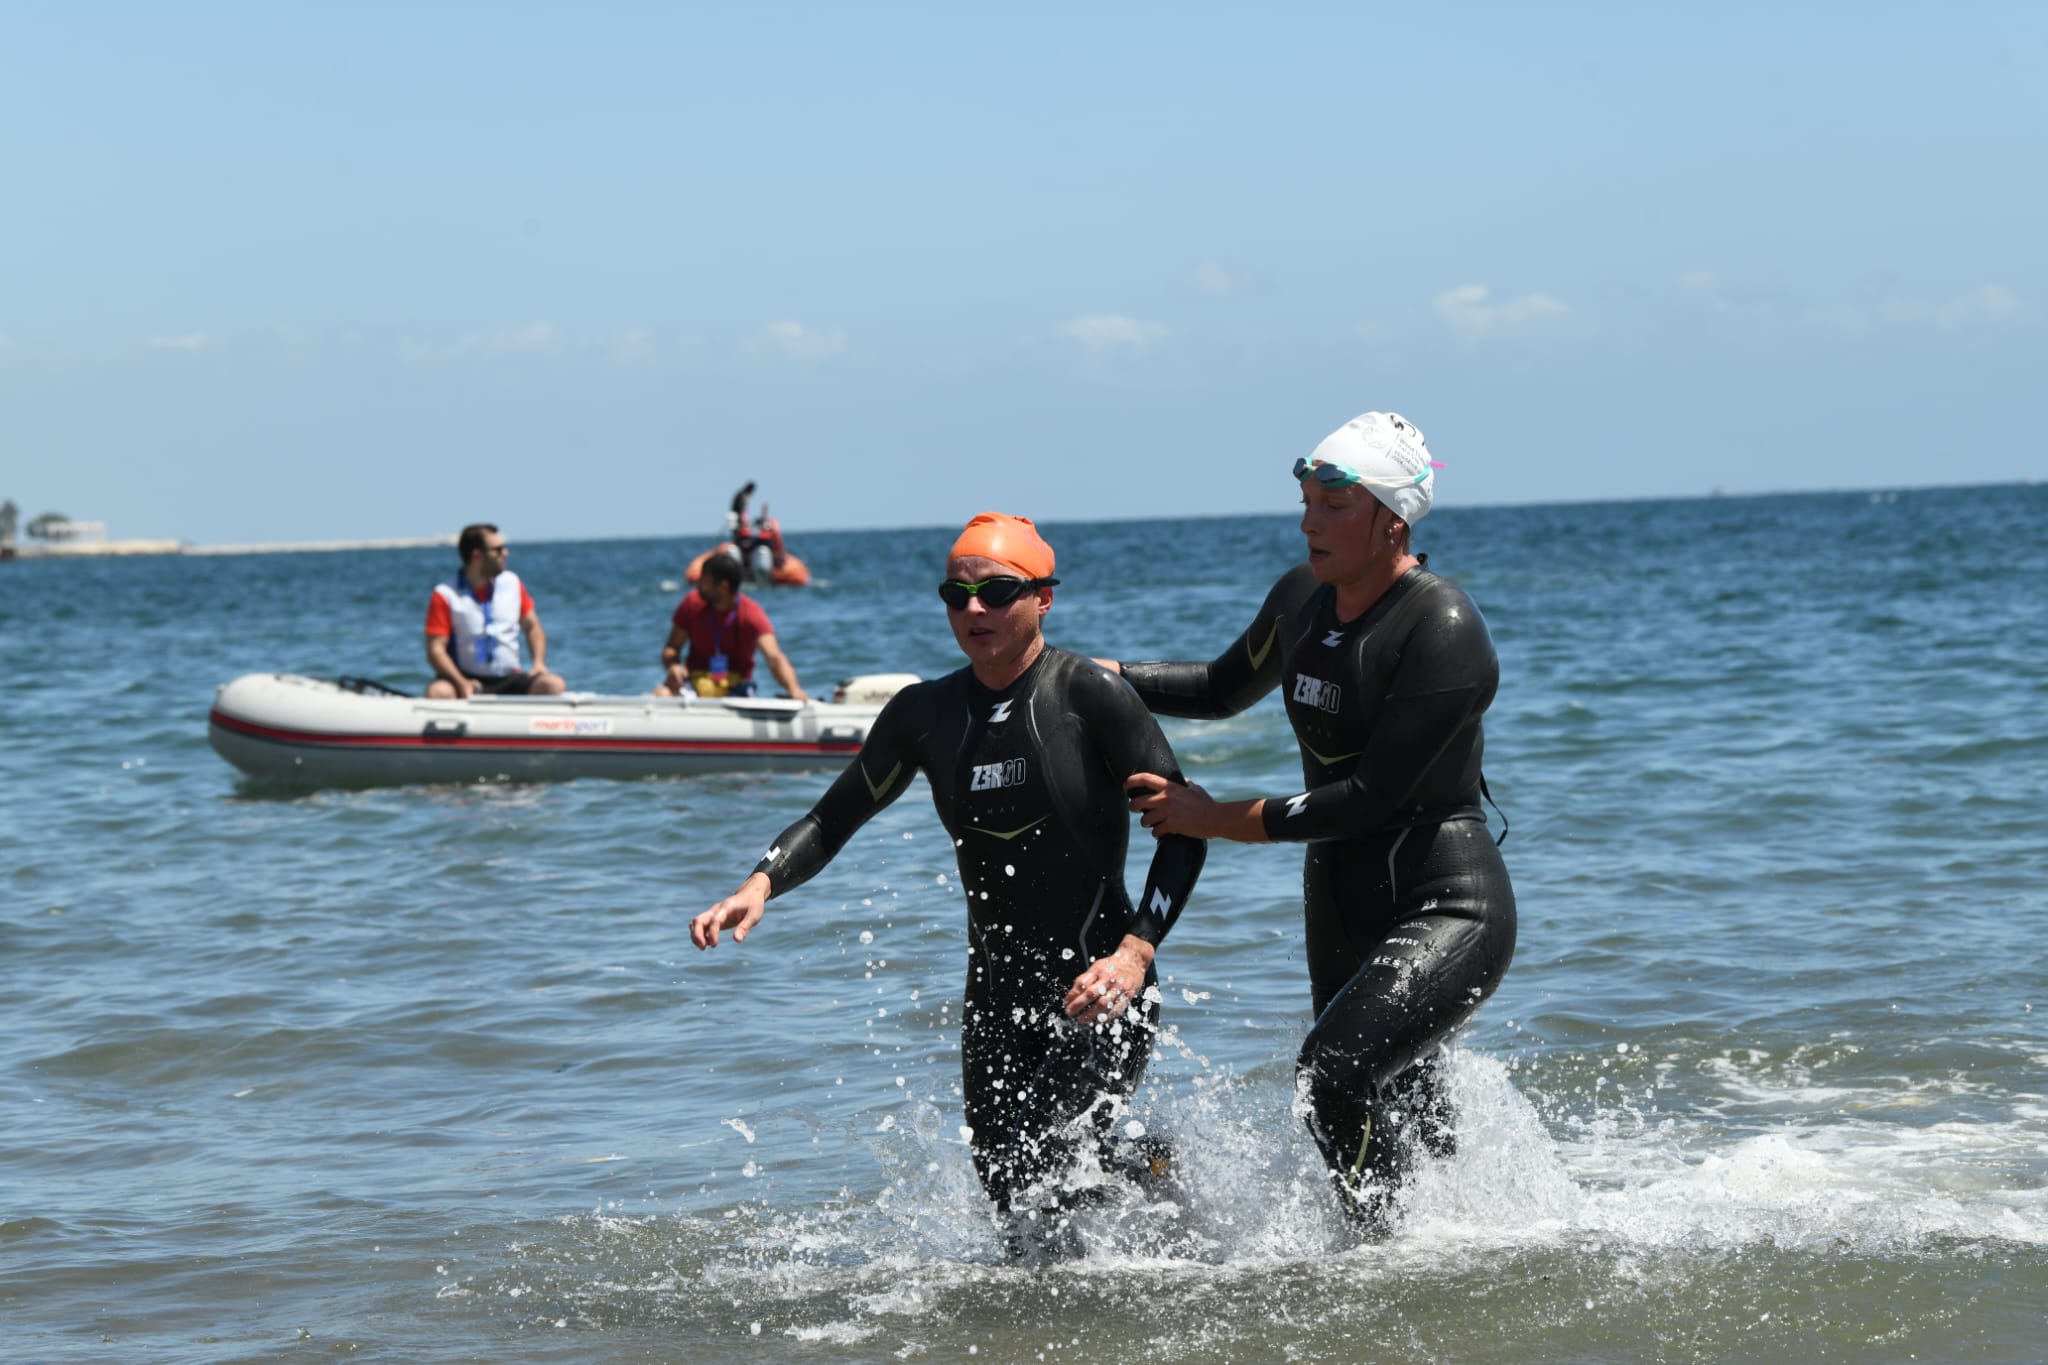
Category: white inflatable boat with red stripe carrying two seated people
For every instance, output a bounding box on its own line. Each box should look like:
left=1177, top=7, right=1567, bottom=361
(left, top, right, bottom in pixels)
left=207, top=673, right=918, bottom=786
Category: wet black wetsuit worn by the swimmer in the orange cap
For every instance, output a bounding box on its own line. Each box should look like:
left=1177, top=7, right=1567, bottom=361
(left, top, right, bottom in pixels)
left=756, top=647, right=1208, bottom=1207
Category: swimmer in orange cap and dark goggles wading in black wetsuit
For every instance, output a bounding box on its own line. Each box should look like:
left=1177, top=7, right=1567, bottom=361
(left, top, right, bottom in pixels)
left=690, top=512, right=1206, bottom=1228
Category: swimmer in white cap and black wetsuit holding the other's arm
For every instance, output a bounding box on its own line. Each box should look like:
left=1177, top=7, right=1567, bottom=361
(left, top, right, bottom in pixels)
left=1110, top=413, right=1516, bottom=1230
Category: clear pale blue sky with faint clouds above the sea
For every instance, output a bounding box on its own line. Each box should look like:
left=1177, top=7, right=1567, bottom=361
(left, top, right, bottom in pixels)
left=0, top=0, right=2048, bottom=548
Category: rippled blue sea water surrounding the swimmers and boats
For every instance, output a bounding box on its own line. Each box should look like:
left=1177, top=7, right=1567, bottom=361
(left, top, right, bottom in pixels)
left=0, top=485, right=2048, bottom=1363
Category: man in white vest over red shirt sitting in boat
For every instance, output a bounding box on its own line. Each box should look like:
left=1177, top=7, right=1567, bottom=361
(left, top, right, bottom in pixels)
left=426, top=522, right=567, bottom=698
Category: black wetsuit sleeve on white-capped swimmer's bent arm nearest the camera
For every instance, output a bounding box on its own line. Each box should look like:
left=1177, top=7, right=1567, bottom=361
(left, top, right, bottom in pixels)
left=1262, top=602, right=1501, bottom=841
